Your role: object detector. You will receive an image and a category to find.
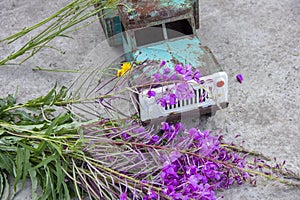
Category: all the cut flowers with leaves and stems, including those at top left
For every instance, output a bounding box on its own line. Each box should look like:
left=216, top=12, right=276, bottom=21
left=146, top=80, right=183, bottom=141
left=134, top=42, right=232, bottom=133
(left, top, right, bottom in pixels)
left=0, top=0, right=300, bottom=200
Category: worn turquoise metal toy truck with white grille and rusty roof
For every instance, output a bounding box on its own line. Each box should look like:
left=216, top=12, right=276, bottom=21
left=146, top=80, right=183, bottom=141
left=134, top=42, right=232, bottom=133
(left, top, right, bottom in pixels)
left=97, top=0, right=228, bottom=122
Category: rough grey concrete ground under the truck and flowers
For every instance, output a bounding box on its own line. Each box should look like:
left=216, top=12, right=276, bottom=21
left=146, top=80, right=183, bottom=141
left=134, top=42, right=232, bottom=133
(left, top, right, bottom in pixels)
left=0, top=0, right=300, bottom=200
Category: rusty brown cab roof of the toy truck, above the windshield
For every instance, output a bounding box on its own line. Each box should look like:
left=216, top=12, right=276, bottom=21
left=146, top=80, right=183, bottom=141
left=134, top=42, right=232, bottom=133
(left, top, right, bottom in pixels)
left=118, top=0, right=199, bottom=30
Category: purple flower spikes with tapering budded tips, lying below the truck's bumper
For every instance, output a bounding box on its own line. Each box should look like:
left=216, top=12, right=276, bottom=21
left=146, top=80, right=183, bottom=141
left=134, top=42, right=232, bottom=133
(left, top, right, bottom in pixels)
left=109, top=119, right=298, bottom=200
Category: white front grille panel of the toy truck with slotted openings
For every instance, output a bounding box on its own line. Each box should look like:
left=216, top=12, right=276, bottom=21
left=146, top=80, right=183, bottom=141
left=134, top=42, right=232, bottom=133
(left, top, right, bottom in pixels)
left=138, top=72, right=228, bottom=121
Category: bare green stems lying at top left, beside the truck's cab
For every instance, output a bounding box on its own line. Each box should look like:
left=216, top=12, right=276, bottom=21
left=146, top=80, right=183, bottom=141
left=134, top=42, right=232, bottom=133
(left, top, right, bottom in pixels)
left=0, top=0, right=119, bottom=66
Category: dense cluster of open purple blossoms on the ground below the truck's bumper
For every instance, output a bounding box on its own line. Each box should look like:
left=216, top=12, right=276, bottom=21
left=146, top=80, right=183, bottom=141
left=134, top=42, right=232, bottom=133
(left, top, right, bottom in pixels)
left=138, top=122, right=250, bottom=200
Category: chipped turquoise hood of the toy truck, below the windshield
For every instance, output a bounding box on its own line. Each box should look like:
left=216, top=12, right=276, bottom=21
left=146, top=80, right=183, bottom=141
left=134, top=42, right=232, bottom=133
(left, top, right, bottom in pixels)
left=129, top=35, right=222, bottom=84
